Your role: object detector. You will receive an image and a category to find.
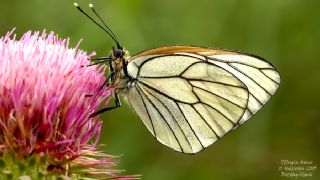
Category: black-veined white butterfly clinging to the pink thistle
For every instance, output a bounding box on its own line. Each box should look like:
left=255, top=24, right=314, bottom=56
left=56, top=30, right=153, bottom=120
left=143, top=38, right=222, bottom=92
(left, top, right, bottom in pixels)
left=75, top=3, right=280, bottom=154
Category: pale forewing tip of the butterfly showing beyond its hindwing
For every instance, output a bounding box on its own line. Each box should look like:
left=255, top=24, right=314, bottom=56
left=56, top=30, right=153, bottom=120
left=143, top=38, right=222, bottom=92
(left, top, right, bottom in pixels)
left=206, top=53, right=280, bottom=124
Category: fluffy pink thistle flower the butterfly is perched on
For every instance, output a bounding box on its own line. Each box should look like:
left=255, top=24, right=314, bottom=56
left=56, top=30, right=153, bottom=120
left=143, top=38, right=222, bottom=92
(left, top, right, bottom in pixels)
left=0, top=31, right=131, bottom=179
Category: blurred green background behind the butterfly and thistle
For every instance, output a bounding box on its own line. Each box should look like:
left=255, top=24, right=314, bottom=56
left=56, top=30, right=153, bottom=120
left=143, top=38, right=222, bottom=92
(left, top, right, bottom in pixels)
left=0, top=0, right=320, bottom=180
